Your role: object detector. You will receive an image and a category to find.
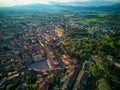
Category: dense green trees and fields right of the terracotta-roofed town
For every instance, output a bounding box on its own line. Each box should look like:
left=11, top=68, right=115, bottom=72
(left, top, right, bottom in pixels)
left=60, top=11, right=120, bottom=90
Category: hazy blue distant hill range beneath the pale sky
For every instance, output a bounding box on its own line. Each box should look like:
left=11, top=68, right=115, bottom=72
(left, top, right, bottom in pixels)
left=1, top=3, right=120, bottom=10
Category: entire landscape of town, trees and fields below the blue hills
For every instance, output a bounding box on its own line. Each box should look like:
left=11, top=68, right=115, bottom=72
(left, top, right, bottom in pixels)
left=0, top=0, right=120, bottom=90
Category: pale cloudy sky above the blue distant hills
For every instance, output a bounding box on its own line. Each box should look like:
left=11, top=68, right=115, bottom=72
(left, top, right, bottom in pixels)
left=0, top=0, right=120, bottom=7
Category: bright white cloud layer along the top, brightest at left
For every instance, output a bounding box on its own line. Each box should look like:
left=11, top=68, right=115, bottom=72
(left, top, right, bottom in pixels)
left=0, top=0, right=120, bottom=6
